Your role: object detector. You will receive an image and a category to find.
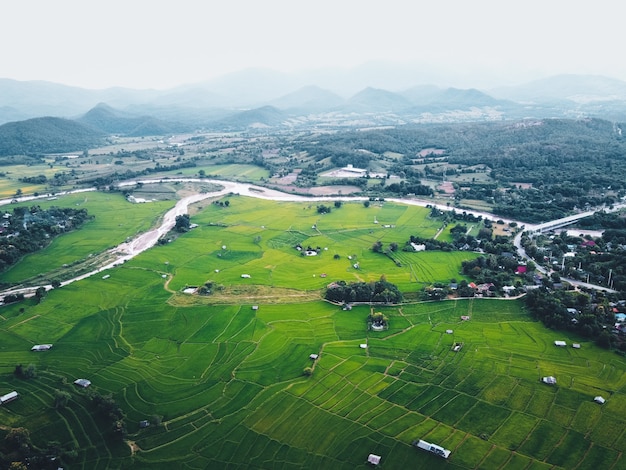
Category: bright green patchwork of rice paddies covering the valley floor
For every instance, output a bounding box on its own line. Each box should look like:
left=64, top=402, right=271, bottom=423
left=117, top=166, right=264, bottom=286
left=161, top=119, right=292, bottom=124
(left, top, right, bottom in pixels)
left=0, top=193, right=626, bottom=470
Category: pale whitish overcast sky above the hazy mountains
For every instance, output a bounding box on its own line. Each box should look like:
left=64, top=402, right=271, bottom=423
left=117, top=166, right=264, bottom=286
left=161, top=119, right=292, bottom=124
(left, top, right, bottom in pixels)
left=0, top=0, right=626, bottom=89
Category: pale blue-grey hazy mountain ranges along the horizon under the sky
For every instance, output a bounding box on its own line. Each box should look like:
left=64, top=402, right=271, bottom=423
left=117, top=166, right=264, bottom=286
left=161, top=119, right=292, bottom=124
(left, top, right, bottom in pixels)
left=0, top=64, right=626, bottom=136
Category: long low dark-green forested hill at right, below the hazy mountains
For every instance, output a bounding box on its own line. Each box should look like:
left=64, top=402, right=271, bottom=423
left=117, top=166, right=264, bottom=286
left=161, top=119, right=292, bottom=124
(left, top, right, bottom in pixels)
left=300, top=119, right=626, bottom=187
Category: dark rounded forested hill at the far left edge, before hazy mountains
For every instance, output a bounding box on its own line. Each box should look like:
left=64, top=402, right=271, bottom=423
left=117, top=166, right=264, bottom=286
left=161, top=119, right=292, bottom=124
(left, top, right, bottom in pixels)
left=0, top=117, right=104, bottom=156
